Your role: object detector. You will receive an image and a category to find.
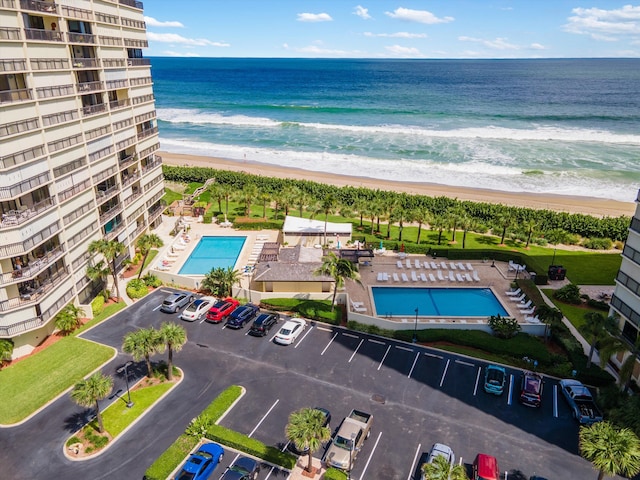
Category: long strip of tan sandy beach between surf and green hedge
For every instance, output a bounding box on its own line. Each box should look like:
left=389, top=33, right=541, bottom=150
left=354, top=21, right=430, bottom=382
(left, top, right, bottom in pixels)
left=160, top=152, right=635, bottom=217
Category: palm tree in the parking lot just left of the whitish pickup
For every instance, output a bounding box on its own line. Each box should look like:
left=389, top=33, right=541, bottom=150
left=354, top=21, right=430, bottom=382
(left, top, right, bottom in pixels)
left=284, top=408, right=331, bottom=472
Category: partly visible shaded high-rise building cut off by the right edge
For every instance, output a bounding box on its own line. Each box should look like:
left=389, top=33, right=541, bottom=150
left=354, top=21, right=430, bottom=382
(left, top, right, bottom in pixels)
left=611, top=192, right=640, bottom=380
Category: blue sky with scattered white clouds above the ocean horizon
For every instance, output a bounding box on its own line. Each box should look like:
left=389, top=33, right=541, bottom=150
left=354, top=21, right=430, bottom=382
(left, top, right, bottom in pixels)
left=144, top=0, right=640, bottom=58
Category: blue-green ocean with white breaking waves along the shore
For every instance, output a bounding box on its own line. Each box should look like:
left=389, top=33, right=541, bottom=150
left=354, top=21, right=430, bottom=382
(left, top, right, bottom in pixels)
left=151, top=58, right=640, bottom=202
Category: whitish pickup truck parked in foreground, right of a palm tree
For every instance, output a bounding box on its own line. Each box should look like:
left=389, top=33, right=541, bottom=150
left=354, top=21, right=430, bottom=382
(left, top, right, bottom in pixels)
left=322, top=410, right=373, bottom=471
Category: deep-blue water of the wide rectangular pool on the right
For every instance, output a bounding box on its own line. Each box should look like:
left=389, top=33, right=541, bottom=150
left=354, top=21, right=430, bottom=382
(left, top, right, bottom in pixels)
left=371, top=287, right=508, bottom=317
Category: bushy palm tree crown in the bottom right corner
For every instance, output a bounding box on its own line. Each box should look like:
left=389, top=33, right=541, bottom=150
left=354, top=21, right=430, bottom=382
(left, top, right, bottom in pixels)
left=579, top=422, right=640, bottom=480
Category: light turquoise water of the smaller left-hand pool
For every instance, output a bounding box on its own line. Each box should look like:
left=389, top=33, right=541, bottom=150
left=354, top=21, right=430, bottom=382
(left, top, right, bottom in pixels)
left=178, top=237, right=247, bottom=275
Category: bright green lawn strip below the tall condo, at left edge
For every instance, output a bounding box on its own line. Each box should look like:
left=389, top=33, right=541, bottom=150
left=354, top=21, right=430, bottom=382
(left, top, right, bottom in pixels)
left=0, top=337, right=114, bottom=425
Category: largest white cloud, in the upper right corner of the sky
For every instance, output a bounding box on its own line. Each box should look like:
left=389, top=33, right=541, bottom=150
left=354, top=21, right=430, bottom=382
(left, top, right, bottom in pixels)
left=564, top=5, right=640, bottom=41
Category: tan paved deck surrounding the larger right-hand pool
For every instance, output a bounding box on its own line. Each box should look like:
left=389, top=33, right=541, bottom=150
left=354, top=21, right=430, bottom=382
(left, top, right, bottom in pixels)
left=346, top=252, right=528, bottom=324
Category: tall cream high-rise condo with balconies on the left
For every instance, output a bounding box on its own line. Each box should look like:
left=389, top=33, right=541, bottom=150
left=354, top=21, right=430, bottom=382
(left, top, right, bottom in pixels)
left=0, top=0, right=164, bottom=357
